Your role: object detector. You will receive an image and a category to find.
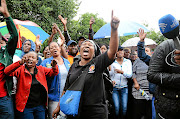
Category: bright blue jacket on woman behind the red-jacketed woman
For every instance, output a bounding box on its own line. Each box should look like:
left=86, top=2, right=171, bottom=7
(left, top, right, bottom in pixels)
left=41, top=56, right=70, bottom=102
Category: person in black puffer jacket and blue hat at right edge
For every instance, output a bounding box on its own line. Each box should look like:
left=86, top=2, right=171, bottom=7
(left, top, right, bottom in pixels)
left=148, top=14, right=180, bottom=119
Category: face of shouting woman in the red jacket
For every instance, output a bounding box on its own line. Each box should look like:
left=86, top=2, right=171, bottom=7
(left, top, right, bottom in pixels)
left=26, top=52, right=38, bottom=68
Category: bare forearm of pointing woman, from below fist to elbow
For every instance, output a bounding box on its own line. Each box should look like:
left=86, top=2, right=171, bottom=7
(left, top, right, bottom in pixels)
left=108, top=29, right=119, bottom=60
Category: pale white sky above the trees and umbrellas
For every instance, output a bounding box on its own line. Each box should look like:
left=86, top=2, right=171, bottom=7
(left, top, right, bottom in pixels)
left=75, top=0, right=180, bottom=32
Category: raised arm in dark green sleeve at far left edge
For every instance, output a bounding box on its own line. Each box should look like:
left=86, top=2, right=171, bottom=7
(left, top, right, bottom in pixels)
left=0, top=0, right=18, bottom=56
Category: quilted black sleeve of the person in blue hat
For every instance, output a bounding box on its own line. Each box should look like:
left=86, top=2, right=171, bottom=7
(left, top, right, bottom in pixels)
left=147, top=44, right=180, bottom=89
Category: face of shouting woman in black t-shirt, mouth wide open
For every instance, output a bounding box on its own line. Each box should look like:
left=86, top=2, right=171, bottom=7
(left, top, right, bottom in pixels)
left=80, top=41, right=94, bottom=60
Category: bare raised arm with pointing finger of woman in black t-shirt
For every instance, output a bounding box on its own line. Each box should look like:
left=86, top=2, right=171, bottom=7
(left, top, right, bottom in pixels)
left=107, top=11, right=120, bottom=60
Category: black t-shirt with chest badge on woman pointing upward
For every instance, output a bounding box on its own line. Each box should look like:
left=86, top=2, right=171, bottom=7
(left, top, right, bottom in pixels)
left=64, top=52, right=113, bottom=107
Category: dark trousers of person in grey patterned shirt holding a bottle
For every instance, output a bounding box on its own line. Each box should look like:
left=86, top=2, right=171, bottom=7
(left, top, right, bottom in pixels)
left=133, top=99, right=152, bottom=119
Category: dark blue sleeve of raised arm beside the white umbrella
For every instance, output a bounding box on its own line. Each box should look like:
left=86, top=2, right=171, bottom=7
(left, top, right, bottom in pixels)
left=137, top=41, right=151, bottom=65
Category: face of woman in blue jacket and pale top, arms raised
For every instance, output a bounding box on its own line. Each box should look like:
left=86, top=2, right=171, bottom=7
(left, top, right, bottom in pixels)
left=49, top=42, right=61, bottom=57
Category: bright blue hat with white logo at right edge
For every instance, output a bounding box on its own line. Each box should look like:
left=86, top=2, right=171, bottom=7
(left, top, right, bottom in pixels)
left=159, top=14, right=179, bottom=34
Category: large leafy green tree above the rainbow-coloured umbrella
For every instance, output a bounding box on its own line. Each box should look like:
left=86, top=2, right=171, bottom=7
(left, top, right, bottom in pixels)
left=7, top=0, right=80, bottom=34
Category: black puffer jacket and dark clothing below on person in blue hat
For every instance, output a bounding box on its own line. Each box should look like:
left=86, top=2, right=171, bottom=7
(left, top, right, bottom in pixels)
left=148, top=40, right=180, bottom=119
